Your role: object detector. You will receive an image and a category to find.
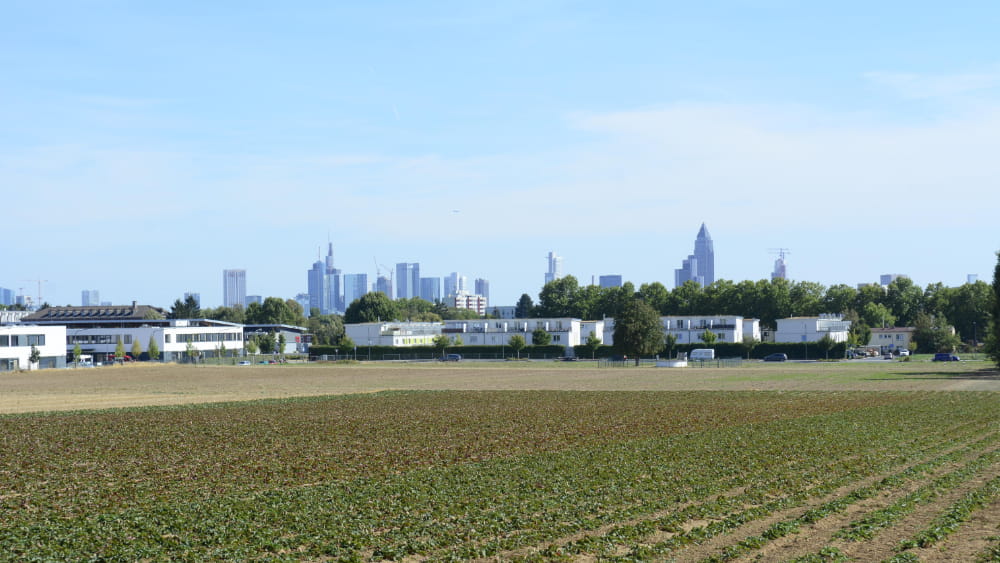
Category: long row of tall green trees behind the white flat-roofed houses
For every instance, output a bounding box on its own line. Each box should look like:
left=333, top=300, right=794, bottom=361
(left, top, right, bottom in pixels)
left=515, top=276, right=996, bottom=342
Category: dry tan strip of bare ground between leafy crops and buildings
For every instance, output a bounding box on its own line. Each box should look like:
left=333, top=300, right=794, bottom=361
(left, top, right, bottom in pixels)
left=0, top=362, right=1000, bottom=413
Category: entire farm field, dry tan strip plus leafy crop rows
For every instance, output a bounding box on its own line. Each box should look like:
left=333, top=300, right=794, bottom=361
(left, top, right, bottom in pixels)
left=0, top=362, right=1000, bottom=561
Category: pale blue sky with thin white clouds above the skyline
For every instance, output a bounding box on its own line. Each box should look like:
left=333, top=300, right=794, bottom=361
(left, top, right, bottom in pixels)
left=0, top=0, right=1000, bottom=307
